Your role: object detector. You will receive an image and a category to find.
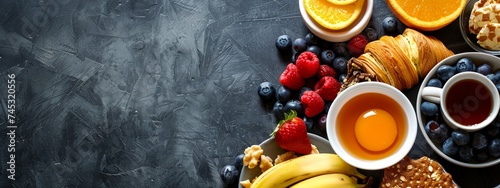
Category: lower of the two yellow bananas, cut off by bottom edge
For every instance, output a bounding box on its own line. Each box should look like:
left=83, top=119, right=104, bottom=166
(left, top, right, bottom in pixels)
left=290, top=173, right=367, bottom=188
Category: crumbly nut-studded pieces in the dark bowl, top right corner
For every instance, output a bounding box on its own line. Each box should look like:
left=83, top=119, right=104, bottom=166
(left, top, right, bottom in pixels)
left=469, top=0, right=500, bottom=50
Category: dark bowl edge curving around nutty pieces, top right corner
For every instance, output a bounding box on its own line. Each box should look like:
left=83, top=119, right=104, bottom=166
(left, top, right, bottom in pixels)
left=458, top=0, right=500, bottom=55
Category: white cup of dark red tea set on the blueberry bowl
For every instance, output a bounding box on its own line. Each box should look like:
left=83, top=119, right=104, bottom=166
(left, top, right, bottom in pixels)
left=422, top=72, right=500, bottom=132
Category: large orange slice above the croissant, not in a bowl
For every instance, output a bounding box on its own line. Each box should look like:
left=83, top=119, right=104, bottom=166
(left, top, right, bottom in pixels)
left=386, top=0, right=467, bottom=31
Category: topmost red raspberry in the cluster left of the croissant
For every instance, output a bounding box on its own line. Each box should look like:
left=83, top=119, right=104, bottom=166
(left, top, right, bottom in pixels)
left=295, top=51, right=319, bottom=78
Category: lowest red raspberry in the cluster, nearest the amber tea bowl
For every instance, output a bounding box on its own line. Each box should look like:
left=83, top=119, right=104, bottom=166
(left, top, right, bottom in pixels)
left=300, top=91, right=325, bottom=117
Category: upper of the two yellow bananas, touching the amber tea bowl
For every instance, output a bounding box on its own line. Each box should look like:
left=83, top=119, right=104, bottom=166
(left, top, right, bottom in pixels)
left=252, top=153, right=366, bottom=188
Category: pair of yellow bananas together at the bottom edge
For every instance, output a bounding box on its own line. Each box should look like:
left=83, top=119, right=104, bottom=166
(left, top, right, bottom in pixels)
left=252, top=153, right=371, bottom=188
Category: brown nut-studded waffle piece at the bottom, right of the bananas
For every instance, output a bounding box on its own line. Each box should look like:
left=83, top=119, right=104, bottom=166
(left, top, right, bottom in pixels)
left=380, top=156, right=458, bottom=188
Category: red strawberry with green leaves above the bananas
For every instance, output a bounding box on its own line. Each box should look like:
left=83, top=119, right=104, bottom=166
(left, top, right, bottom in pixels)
left=271, top=110, right=312, bottom=154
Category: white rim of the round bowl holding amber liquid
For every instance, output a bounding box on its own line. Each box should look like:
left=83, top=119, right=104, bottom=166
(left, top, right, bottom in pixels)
left=326, top=81, right=418, bottom=170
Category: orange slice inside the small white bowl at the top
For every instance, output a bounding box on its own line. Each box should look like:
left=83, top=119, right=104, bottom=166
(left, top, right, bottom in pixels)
left=303, top=0, right=365, bottom=30
